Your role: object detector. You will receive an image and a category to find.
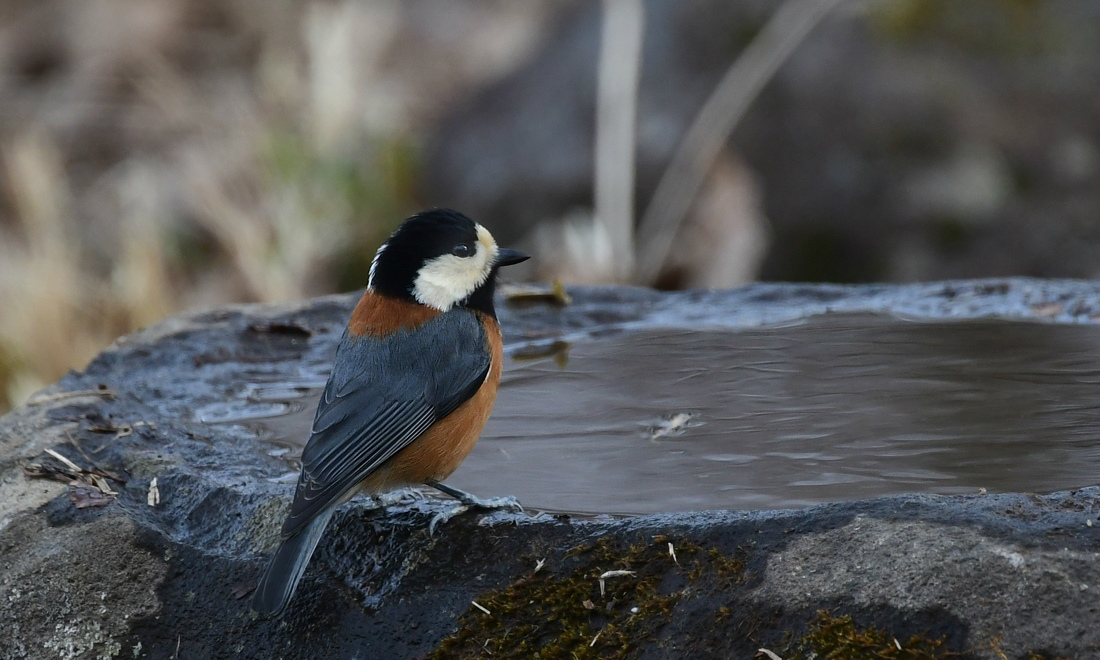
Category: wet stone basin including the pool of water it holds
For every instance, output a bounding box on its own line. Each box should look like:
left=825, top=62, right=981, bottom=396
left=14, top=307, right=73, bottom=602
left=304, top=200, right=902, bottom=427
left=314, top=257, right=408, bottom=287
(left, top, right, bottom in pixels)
left=0, top=279, right=1100, bottom=658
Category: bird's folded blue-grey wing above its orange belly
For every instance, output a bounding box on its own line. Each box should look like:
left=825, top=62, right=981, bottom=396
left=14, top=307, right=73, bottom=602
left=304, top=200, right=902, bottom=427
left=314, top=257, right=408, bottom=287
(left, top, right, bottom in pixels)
left=283, top=308, right=492, bottom=538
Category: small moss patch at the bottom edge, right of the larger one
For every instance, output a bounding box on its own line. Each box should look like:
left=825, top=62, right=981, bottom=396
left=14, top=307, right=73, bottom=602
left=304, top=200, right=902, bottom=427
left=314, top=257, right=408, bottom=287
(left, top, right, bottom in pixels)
left=783, top=612, right=961, bottom=660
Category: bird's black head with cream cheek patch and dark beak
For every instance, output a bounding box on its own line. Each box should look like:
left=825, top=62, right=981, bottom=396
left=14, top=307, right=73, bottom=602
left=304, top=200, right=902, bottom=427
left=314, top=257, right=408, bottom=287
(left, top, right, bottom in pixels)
left=367, top=209, right=528, bottom=317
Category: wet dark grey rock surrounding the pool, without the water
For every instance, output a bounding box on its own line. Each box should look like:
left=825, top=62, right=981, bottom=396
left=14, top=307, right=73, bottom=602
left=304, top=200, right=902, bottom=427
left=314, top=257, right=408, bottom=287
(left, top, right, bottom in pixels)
left=0, top=279, right=1100, bottom=659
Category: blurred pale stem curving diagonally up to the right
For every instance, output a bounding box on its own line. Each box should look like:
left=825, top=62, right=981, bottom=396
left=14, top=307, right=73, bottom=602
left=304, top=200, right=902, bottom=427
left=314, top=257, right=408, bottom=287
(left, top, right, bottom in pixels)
left=635, top=0, right=843, bottom=285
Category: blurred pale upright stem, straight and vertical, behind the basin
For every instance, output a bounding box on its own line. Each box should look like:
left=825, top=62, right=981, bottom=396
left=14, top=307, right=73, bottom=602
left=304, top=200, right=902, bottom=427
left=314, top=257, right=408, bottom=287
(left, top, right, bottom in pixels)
left=595, top=0, right=646, bottom=281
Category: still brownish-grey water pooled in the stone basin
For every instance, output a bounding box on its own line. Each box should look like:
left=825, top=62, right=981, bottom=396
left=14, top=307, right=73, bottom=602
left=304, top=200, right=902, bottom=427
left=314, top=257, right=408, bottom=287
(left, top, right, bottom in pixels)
left=245, top=315, right=1100, bottom=514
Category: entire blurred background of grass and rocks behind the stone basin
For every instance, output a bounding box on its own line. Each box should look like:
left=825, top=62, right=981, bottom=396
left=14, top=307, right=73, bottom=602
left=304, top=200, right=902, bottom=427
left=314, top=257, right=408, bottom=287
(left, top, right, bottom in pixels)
left=0, top=0, right=1100, bottom=410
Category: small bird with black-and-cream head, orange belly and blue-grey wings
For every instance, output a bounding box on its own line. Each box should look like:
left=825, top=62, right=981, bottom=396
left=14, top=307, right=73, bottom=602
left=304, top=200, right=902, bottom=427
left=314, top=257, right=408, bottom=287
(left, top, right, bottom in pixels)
left=252, top=209, right=529, bottom=616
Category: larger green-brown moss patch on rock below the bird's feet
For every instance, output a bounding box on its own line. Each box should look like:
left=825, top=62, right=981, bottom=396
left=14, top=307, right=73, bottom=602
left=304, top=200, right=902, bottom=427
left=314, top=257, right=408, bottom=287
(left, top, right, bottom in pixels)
left=429, top=536, right=744, bottom=660
